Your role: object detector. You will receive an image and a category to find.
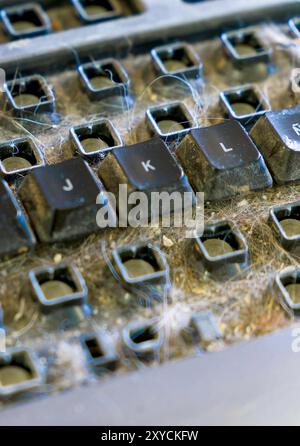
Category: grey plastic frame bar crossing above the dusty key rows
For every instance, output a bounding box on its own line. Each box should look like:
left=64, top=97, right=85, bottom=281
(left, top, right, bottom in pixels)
left=0, top=0, right=300, bottom=72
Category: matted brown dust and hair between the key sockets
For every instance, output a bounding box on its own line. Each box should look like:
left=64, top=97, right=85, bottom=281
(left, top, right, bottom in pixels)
left=0, top=23, right=300, bottom=400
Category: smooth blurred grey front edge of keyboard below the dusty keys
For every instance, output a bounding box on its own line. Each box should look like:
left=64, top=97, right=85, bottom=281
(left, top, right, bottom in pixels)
left=0, top=330, right=300, bottom=426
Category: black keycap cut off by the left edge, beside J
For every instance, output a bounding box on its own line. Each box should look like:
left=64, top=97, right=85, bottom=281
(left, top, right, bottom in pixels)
left=0, top=180, right=35, bottom=259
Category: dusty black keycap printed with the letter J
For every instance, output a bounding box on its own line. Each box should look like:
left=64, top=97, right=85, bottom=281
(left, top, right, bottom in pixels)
left=19, top=158, right=105, bottom=242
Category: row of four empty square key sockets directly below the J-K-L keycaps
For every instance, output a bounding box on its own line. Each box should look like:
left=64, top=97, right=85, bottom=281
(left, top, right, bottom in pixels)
left=3, top=220, right=300, bottom=314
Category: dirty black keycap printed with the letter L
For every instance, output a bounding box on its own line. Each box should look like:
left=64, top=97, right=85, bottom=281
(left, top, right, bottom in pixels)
left=176, top=121, right=272, bottom=200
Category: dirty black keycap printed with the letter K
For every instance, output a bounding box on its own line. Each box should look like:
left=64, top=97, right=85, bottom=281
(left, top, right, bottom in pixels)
left=99, top=138, right=192, bottom=218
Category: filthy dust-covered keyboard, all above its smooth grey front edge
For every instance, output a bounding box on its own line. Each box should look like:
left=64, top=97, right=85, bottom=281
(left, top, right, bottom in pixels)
left=0, top=0, right=300, bottom=426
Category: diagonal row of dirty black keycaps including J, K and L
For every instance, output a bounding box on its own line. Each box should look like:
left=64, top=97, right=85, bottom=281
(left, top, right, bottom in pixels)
left=0, top=106, right=299, bottom=257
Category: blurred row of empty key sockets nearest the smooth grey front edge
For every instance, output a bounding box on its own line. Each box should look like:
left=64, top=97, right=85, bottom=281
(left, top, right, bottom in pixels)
left=0, top=304, right=223, bottom=400
